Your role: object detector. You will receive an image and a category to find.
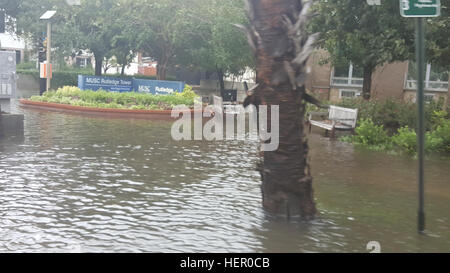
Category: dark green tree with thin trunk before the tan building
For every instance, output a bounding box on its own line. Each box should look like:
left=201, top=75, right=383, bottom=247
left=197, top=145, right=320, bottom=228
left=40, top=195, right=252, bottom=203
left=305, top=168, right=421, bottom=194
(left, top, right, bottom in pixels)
left=311, top=0, right=414, bottom=100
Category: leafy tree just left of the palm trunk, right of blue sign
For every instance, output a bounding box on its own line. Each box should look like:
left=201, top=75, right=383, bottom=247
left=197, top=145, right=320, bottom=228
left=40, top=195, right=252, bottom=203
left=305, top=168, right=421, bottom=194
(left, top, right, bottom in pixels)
left=179, top=0, right=254, bottom=91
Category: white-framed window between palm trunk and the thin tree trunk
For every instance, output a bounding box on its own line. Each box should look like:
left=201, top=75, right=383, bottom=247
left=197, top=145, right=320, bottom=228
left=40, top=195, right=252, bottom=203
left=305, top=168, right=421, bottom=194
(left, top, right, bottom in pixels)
left=331, top=63, right=364, bottom=87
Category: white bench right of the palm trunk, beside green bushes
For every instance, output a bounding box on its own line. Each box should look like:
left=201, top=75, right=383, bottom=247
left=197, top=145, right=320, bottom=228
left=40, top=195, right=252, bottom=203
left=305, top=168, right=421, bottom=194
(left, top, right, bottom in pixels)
left=308, top=105, right=358, bottom=137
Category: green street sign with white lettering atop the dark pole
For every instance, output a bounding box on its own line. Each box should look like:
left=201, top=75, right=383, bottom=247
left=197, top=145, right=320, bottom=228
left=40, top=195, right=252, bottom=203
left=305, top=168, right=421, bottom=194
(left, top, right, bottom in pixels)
left=400, top=0, right=441, bottom=17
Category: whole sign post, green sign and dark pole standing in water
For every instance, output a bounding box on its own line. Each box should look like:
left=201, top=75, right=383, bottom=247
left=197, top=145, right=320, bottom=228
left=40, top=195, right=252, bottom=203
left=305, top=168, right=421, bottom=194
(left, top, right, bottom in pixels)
left=400, top=0, right=441, bottom=234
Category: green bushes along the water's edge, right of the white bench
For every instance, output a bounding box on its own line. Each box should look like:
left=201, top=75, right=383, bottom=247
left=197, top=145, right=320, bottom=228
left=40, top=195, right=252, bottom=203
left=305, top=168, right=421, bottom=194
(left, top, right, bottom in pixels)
left=341, top=101, right=450, bottom=153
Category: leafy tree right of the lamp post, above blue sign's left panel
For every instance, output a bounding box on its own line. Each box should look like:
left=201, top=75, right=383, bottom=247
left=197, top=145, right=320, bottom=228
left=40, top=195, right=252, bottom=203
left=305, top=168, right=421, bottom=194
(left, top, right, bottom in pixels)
left=59, top=0, right=137, bottom=76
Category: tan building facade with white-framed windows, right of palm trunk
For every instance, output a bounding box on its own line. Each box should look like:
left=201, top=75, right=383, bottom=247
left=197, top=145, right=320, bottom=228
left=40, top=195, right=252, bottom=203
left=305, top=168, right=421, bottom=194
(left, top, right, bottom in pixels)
left=306, top=50, right=450, bottom=104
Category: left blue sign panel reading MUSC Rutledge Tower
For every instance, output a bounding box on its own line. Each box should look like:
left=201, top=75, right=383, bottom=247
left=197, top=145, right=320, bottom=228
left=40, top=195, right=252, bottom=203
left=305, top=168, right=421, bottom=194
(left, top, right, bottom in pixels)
left=78, top=75, right=133, bottom=92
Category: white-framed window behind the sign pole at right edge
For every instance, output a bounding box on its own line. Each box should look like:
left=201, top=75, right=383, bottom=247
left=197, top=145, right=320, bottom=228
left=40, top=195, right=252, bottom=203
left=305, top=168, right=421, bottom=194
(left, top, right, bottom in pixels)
left=405, top=62, right=449, bottom=92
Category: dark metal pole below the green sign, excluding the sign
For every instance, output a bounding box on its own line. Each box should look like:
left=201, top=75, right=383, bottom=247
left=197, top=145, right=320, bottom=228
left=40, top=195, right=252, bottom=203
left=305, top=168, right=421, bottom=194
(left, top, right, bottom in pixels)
left=416, top=17, right=425, bottom=233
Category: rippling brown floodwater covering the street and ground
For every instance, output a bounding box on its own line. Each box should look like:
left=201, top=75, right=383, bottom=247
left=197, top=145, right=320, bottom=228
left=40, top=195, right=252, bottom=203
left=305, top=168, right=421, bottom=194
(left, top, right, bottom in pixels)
left=0, top=101, right=450, bottom=252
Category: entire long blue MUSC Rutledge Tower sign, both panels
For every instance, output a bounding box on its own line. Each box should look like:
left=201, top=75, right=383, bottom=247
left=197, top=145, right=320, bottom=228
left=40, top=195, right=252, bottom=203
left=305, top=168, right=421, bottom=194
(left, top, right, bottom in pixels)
left=78, top=75, right=185, bottom=95
